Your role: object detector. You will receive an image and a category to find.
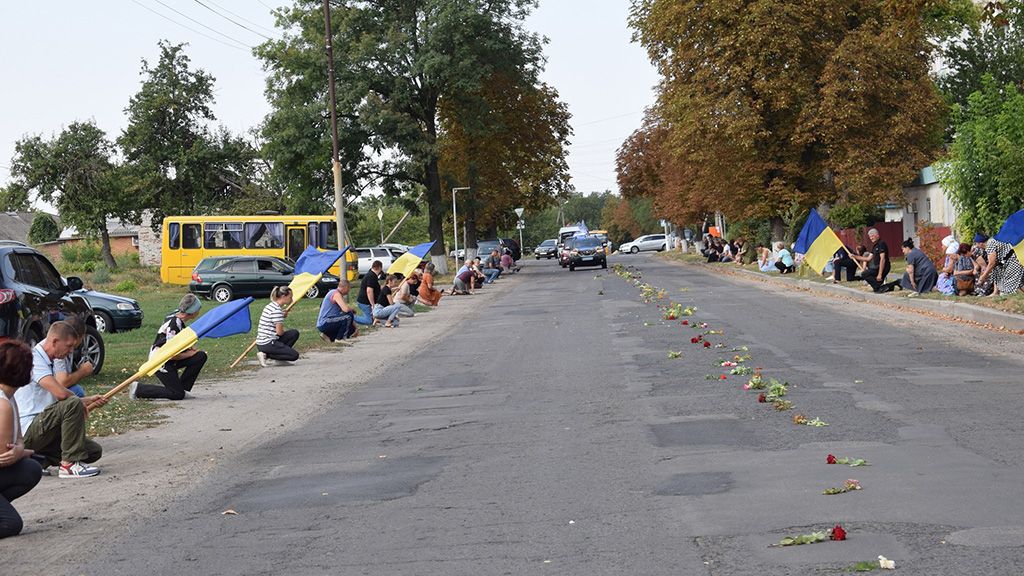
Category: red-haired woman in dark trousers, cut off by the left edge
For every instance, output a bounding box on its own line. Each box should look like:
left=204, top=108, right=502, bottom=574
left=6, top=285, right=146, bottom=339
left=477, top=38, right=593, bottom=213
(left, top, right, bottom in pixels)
left=0, top=340, right=43, bottom=538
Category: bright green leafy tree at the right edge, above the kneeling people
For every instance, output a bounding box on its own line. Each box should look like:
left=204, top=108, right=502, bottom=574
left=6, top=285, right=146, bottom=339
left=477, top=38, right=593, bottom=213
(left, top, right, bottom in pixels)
left=939, top=76, right=1024, bottom=237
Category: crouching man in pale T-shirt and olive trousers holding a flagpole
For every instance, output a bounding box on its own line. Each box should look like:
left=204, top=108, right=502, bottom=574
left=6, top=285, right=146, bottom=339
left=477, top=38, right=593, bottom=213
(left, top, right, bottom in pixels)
left=14, top=322, right=106, bottom=478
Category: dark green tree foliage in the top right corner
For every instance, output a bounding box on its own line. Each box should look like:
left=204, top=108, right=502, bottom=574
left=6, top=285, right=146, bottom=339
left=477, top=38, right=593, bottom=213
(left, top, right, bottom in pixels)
left=936, top=0, right=1024, bottom=107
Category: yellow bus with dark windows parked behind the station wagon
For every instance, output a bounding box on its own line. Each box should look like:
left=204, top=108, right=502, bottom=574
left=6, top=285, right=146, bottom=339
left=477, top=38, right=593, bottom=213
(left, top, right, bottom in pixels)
left=160, top=214, right=358, bottom=284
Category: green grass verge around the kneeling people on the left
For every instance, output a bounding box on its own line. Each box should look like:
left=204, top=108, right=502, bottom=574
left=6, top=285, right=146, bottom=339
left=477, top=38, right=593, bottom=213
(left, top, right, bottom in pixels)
left=75, top=269, right=431, bottom=437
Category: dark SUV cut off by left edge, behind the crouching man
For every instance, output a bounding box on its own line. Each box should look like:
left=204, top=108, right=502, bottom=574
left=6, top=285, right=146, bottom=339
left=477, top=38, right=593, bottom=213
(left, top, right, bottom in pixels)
left=0, top=240, right=105, bottom=373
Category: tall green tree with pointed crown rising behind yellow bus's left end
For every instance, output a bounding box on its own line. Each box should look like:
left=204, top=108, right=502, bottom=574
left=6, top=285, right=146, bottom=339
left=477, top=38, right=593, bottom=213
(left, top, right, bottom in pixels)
left=118, top=41, right=257, bottom=227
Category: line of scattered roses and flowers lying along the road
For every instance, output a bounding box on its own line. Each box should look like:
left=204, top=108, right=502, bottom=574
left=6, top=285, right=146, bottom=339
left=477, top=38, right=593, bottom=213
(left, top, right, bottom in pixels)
left=614, top=264, right=895, bottom=569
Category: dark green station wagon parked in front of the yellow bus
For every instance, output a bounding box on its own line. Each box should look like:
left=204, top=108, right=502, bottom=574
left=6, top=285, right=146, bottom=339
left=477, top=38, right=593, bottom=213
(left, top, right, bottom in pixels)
left=188, top=256, right=338, bottom=302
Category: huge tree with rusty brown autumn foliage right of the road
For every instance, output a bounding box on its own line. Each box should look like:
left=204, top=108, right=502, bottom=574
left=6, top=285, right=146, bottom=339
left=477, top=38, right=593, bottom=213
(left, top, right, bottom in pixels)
left=630, top=0, right=946, bottom=230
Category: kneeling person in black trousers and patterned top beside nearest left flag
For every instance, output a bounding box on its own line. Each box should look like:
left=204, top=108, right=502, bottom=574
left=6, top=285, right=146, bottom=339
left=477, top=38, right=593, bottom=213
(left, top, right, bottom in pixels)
left=134, top=294, right=207, bottom=400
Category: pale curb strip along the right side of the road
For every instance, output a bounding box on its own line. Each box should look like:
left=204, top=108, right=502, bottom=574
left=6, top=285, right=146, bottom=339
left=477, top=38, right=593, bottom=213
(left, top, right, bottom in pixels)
left=669, top=255, right=1024, bottom=333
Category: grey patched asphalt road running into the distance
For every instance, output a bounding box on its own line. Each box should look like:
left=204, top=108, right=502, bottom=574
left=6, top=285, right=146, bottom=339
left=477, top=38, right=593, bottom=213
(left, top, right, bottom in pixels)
left=77, top=255, right=1024, bottom=576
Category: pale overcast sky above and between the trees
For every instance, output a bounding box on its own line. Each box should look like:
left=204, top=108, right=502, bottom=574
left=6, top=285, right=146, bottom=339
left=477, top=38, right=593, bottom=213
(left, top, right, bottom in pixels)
left=0, top=0, right=657, bottom=193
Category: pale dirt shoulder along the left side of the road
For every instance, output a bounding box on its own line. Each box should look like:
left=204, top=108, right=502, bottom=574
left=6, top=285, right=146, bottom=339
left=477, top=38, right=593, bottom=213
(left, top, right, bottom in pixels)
left=0, top=275, right=524, bottom=575
